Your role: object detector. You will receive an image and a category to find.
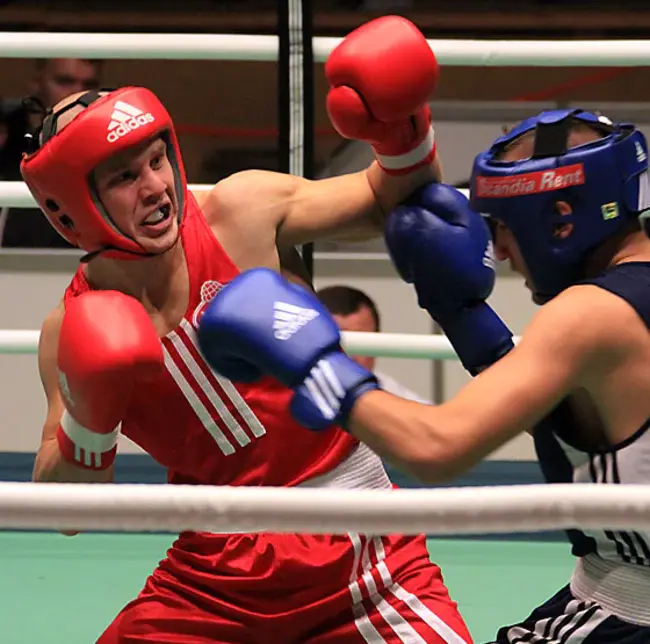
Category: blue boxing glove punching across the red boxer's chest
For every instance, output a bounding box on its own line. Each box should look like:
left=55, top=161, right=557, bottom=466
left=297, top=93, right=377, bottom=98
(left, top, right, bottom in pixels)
left=198, top=268, right=379, bottom=430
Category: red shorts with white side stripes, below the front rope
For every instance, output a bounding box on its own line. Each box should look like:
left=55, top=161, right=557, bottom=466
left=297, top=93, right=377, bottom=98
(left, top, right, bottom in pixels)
left=97, top=533, right=472, bottom=644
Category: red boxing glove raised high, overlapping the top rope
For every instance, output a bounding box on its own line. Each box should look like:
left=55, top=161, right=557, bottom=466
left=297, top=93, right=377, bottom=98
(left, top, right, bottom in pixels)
left=325, top=16, right=439, bottom=174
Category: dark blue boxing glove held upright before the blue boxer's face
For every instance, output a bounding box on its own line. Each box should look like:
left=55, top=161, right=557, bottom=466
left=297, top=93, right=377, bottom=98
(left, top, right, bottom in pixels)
left=386, top=183, right=514, bottom=375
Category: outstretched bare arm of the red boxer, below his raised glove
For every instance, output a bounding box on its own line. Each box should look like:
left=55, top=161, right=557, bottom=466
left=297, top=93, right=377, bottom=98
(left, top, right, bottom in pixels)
left=205, top=158, right=441, bottom=245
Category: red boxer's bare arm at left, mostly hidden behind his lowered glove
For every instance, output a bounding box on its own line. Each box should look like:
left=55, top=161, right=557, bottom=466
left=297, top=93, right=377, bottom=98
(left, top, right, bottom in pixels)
left=32, top=304, right=113, bottom=483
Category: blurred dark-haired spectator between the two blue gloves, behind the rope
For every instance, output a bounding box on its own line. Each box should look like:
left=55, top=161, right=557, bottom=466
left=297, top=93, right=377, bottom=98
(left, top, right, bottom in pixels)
left=316, top=285, right=431, bottom=404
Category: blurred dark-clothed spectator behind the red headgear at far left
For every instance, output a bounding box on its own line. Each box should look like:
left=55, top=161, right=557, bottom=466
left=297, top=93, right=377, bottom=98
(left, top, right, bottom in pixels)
left=0, top=58, right=101, bottom=248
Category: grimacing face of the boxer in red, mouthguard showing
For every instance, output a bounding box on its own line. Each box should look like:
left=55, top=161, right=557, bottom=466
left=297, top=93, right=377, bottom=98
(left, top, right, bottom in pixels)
left=94, top=138, right=179, bottom=254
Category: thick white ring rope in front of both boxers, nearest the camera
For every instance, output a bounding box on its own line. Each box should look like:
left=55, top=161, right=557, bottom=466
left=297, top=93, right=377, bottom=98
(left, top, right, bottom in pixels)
left=0, top=483, right=650, bottom=535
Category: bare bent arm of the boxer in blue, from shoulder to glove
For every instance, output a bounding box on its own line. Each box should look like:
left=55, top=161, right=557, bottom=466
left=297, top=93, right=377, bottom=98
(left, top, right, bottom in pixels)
left=350, top=286, right=632, bottom=482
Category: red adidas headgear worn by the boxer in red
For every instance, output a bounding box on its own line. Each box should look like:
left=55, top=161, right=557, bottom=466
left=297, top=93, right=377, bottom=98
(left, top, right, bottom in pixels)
left=20, top=87, right=187, bottom=259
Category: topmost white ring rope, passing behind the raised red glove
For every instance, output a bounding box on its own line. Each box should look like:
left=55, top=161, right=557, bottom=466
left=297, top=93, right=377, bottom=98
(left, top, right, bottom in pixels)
left=0, top=32, right=650, bottom=67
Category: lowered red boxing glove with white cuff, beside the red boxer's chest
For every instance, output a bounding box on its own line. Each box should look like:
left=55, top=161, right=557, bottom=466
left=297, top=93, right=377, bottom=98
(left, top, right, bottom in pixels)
left=57, top=291, right=164, bottom=470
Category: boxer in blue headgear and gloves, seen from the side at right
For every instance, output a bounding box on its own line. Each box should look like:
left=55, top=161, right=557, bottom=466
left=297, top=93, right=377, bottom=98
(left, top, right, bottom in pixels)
left=199, top=110, right=650, bottom=644
